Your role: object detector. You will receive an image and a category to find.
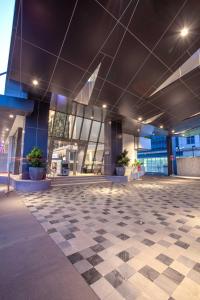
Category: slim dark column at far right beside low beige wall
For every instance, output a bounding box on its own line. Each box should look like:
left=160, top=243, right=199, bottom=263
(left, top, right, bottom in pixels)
left=167, top=135, right=177, bottom=176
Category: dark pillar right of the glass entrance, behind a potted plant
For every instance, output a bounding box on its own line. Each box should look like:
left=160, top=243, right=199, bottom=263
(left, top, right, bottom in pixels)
left=104, top=121, right=122, bottom=175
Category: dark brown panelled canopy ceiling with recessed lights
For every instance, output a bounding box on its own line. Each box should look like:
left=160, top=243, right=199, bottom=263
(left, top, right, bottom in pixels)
left=9, top=0, right=200, bottom=128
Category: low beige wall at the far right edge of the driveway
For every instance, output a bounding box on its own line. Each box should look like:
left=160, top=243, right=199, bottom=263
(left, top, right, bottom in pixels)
left=177, top=157, right=200, bottom=177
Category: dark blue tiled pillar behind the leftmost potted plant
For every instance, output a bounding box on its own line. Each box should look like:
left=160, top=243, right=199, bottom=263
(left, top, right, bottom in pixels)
left=22, top=101, right=49, bottom=179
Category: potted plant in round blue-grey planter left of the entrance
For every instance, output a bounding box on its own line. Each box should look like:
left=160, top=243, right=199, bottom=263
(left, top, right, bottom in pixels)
left=27, top=147, right=45, bottom=180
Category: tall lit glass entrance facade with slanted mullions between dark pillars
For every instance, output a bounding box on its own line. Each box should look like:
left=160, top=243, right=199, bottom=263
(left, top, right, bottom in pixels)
left=49, top=97, right=105, bottom=173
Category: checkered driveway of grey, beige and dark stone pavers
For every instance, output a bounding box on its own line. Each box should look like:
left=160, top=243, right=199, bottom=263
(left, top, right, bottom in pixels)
left=22, top=178, right=200, bottom=300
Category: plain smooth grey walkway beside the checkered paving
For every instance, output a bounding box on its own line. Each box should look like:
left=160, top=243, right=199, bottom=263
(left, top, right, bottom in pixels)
left=0, top=193, right=97, bottom=300
